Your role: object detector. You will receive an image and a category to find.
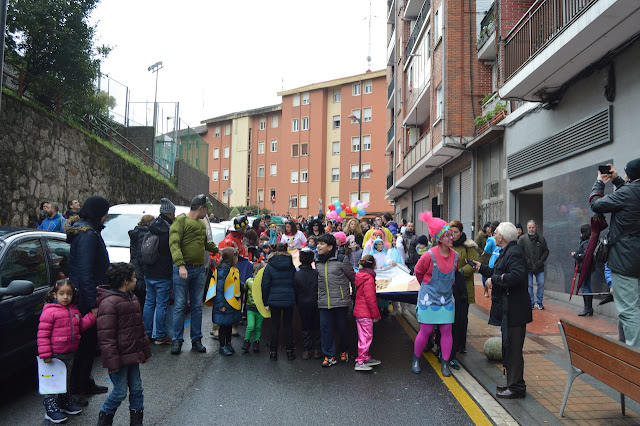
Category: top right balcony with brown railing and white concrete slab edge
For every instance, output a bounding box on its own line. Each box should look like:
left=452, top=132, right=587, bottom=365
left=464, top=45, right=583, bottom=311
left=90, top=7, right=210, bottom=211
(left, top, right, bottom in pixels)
left=500, top=0, right=640, bottom=101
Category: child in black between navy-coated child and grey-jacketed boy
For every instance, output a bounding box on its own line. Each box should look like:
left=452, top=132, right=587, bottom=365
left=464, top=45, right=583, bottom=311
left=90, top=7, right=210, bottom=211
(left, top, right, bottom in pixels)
left=293, top=247, right=320, bottom=359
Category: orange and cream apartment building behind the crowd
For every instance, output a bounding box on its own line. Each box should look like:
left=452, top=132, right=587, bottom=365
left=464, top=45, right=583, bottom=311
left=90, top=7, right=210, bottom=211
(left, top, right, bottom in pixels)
left=202, top=70, right=393, bottom=216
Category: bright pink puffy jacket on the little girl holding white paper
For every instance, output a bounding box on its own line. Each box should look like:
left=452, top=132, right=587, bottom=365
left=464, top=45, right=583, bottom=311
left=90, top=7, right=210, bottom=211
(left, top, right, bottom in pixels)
left=38, top=303, right=96, bottom=358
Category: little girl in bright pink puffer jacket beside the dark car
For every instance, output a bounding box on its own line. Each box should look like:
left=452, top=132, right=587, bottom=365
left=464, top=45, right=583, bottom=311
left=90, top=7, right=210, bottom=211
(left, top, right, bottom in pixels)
left=38, top=279, right=96, bottom=423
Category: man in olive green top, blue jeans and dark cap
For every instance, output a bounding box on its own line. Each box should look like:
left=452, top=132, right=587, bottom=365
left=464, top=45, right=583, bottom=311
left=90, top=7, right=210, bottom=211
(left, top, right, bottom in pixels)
left=169, top=194, right=218, bottom=355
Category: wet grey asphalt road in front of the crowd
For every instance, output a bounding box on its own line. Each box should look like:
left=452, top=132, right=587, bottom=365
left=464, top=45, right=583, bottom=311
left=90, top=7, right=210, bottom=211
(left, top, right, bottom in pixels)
left=0, top=307, right=473, bottom=425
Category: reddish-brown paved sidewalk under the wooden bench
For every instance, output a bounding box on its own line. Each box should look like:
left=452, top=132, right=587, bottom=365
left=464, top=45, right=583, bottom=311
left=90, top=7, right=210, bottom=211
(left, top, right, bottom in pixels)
left=458, top=280, right=640, bottom=425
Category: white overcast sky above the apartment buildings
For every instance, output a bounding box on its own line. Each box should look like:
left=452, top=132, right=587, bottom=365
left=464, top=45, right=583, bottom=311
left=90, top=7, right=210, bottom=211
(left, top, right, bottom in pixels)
left=91, top=0, right=387, bottom=130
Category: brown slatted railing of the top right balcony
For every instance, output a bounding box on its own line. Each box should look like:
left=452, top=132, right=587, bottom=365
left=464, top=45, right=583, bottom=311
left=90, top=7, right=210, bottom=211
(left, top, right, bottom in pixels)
left=505, top=0, right=598, bottom=79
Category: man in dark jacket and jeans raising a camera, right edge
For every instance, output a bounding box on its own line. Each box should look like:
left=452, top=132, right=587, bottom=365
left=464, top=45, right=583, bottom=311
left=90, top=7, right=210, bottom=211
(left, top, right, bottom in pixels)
left=589, top=158, right=640, bottom=348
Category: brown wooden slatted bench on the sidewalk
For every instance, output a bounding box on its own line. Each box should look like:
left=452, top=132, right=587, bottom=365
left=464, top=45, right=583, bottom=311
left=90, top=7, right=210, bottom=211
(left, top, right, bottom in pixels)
left=558, top=318, right=640, bottom=417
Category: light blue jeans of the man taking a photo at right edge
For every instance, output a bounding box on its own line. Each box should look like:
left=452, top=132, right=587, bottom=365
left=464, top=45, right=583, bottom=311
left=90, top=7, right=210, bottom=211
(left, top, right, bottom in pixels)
left=611, top=272, right=640, bottom=348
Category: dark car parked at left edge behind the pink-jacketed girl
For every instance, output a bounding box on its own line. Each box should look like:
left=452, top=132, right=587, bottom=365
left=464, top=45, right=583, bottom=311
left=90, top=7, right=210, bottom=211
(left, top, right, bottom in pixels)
left=0, top=226, right=69, bottom=381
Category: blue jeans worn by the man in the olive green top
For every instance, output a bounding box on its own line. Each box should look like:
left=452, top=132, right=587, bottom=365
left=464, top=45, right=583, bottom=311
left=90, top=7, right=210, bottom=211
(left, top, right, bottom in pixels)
left=173, top=265, right=204, bottom=342
